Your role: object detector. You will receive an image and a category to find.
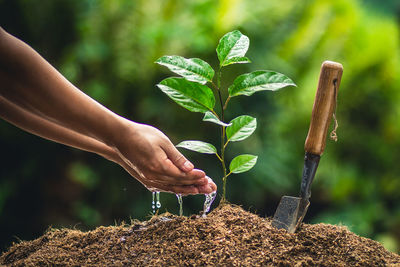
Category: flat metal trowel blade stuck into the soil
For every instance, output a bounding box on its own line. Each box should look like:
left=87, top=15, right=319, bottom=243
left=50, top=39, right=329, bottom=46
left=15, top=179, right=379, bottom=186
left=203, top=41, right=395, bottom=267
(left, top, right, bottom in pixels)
left=272, top=196, right=310, bottom=233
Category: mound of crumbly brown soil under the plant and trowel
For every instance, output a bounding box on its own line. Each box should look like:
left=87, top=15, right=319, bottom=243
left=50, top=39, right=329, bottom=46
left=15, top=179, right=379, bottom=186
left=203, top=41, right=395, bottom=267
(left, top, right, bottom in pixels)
left=0, top=205, right=400, bottom=266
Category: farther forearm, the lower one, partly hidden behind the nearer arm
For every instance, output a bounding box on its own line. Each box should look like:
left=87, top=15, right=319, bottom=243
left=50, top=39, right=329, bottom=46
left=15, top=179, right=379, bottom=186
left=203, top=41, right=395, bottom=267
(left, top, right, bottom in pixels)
left=0, top=96, right=120, bottom=162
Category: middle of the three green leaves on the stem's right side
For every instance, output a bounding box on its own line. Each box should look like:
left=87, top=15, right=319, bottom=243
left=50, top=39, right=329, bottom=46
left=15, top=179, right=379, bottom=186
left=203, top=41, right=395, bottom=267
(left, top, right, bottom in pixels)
left=226, top=115, right=257, bottom=142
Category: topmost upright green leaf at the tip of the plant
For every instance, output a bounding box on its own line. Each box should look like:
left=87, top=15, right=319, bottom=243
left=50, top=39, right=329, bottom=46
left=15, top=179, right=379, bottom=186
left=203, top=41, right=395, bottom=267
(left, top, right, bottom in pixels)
left=217, top=30, right=250, bottom=67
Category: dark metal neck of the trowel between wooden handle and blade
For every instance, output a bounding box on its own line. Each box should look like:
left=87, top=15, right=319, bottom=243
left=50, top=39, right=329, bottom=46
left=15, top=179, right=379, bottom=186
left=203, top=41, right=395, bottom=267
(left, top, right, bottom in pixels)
left=300, top=152, right=321, bottom=199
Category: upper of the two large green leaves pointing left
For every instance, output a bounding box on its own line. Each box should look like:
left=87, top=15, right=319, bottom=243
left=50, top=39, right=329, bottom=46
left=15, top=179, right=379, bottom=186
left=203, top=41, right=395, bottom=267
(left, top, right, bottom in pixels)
left=156, top=56, right=214, bottom=84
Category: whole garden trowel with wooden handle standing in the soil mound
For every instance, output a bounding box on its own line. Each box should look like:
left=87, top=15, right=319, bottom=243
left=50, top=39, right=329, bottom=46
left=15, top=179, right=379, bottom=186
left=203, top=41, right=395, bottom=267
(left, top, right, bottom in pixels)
left=272, top=61, right=343, bottom=233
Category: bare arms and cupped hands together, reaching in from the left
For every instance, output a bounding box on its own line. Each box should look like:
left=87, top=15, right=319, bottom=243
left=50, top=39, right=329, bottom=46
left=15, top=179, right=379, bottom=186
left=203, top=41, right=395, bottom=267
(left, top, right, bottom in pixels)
left=0, top=28, right=216, bottom=195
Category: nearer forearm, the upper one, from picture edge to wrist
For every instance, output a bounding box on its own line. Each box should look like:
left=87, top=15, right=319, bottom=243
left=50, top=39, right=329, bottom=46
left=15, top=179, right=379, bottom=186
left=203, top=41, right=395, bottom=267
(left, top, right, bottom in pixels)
left=0, top=28, right=125, bottom=146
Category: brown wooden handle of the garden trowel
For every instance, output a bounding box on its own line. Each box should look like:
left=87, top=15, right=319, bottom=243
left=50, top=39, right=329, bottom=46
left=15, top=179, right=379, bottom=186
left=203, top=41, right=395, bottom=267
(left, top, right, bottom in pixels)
left=304, top=61, right=343, bottom=155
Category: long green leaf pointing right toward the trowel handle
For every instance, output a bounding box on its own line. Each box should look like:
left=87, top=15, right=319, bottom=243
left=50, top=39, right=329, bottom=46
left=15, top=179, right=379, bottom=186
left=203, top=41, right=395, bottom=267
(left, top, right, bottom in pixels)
left=228, top=70, right=296, bottom=97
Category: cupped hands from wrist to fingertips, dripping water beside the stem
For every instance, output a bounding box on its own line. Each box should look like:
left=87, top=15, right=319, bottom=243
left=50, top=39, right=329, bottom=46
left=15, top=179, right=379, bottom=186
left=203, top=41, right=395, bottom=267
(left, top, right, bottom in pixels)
left=111, top=120, right=217, bottom=195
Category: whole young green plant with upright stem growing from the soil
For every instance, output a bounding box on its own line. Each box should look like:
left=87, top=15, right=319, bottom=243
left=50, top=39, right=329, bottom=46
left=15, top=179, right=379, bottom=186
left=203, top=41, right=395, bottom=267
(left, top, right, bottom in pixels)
left=156, top=30, right=296, bottom=202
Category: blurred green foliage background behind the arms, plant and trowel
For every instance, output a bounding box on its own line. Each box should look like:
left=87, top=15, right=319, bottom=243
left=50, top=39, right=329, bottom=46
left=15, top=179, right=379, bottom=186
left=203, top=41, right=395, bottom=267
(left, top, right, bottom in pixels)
left=0, top=0, right=400, bottom=253
